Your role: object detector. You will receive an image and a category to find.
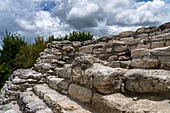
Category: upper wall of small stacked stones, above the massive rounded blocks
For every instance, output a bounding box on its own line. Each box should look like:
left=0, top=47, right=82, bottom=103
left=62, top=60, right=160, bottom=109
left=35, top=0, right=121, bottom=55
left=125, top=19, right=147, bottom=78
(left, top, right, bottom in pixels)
left=34, top=23, right=170, bottom=75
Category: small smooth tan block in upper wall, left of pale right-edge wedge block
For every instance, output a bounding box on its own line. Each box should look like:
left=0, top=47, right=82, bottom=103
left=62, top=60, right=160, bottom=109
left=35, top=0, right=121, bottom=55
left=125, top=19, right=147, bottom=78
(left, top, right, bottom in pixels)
left=131, top=48, right=149, bottom=58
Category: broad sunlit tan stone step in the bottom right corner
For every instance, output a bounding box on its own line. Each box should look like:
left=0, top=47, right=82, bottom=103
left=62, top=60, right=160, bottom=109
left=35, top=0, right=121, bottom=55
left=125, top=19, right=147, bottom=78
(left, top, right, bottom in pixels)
left=92, top=93, right=170, bottom=113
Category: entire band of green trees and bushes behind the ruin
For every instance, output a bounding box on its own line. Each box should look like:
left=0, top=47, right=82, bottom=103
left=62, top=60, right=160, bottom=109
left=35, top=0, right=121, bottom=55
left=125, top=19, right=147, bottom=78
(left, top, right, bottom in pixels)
left=0, top=30, right=93, bottom=89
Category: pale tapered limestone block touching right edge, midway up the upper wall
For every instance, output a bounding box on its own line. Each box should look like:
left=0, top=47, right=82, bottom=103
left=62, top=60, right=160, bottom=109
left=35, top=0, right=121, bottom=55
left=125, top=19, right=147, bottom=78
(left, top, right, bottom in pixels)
left=150, top=46, right=170, bottom=56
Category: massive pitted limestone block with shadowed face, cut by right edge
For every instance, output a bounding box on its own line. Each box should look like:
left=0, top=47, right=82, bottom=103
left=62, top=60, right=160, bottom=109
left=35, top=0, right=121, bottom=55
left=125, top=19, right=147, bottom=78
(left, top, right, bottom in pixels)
left=125, top=69, right=170, bottom=93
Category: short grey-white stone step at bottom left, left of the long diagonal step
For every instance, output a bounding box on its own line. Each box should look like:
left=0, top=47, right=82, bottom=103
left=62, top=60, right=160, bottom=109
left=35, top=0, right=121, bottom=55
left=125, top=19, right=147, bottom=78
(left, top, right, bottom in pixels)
left=18, top=91, right=53, bottom=113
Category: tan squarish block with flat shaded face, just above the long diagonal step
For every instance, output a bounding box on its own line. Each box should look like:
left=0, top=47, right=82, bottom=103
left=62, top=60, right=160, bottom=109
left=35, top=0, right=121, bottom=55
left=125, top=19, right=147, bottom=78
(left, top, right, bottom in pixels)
left=68, top=84, right=92, bottom=103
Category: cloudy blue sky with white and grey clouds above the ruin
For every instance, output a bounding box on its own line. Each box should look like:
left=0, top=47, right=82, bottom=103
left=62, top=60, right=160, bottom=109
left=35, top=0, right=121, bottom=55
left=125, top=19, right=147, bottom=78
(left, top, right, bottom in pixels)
left=0, top=0, right=170, bottom=43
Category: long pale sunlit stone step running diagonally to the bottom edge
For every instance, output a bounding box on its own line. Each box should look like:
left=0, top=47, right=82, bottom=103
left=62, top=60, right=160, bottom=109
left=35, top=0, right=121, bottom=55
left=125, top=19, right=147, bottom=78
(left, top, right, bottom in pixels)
left=33, top=85, right=97, bottom=113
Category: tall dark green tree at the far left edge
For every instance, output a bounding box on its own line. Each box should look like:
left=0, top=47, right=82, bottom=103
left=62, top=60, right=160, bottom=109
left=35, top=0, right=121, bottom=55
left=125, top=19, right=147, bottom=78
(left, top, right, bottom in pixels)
left=0, top=30, right=26, bottom=89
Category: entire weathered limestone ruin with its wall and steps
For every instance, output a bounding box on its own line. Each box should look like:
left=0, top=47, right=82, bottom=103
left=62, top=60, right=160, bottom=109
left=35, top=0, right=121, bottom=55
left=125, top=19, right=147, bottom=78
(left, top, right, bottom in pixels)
left=0, top=22, right=170, bottom=113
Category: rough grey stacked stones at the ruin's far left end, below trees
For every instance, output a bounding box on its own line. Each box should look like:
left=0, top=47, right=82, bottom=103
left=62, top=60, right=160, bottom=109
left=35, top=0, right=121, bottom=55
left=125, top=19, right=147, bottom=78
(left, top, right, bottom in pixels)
left=1, top=69, right=45, bottom=104
